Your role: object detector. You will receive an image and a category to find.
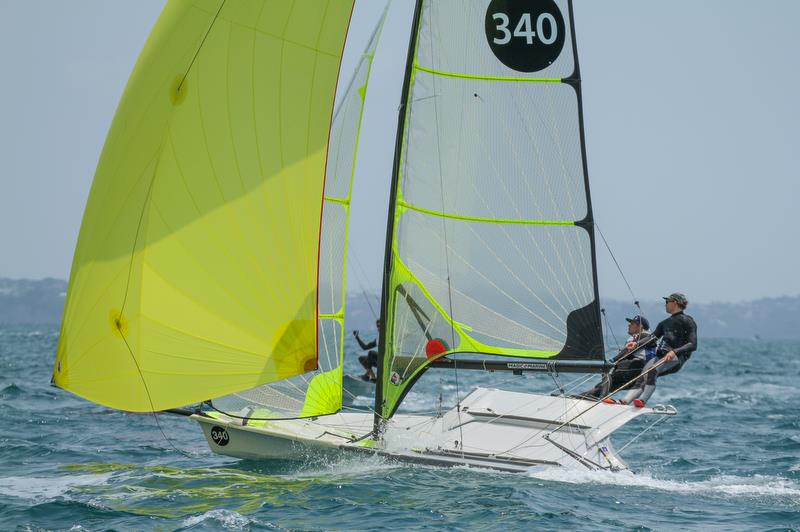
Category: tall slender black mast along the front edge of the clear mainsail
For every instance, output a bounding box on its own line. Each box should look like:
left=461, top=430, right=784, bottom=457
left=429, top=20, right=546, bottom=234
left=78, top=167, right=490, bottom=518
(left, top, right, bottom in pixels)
left=373, top=0, right=423, bottom=437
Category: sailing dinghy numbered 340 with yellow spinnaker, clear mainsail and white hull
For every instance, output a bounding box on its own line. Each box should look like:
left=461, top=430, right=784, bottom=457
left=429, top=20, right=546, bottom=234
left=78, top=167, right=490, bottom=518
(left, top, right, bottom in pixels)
left=53, top=0, right=674, bottom=471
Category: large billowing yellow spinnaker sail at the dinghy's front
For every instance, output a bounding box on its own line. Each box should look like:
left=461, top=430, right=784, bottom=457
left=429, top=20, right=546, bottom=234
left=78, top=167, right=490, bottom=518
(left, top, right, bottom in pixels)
left=53, top=0, right=353, bottom=411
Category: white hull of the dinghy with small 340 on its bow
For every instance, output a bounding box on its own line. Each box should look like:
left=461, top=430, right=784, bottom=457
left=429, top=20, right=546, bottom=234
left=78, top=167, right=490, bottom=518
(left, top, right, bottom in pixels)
left=192, top=388, right=675, bottom=471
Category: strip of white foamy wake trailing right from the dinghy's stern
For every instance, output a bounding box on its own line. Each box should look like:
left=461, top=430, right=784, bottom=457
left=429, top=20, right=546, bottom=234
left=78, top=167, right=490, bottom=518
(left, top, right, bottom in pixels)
left=529, top=468, right=800, bottom=504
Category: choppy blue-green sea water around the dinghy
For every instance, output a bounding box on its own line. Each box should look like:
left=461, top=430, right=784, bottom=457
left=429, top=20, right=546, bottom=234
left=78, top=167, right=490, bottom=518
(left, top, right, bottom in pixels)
left=0, top=326, right=800, bottom=530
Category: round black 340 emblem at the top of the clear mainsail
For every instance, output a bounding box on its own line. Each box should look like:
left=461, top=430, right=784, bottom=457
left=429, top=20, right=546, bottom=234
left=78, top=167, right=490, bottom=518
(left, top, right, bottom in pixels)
left=486, top=0, right=566, bottom=72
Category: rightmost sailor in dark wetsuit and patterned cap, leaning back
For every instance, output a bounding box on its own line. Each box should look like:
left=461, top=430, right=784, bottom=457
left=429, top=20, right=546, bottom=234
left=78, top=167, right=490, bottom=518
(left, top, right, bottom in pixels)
left=623, top=292, right=697, bottom=406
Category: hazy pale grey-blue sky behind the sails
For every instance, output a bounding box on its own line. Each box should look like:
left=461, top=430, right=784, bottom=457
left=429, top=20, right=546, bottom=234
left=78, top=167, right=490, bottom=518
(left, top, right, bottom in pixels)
left=0, top=0, right=800, bottom=302
